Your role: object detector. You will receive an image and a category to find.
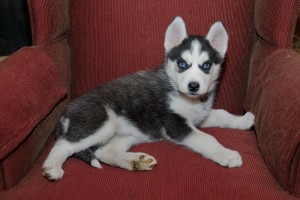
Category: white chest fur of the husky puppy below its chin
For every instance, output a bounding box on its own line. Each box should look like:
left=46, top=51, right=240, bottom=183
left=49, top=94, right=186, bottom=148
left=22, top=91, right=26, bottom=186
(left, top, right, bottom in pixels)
left=170, top=95, right=213, bottom=126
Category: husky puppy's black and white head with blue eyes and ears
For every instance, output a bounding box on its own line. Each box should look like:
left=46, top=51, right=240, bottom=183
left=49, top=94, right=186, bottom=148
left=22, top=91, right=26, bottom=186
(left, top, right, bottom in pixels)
left=164, top=17, right=228, bottom=98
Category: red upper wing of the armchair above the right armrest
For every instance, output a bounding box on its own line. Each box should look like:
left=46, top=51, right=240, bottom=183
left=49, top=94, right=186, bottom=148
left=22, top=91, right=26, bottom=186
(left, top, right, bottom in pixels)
left=248, top=0, right=300, bottom=84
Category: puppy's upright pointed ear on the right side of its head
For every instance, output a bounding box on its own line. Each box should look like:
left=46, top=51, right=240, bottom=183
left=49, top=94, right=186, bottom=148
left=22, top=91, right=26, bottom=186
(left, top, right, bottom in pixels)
left=205, top=21, right=228, bottom=57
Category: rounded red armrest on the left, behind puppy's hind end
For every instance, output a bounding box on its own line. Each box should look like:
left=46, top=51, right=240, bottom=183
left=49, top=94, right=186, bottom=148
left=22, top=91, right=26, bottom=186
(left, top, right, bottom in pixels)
left=0, top=47, right=67, bottom=159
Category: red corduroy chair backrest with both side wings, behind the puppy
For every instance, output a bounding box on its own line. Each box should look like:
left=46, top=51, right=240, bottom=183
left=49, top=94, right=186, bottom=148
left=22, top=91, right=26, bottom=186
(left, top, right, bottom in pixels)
left=28, top=0, right=299, bottom=114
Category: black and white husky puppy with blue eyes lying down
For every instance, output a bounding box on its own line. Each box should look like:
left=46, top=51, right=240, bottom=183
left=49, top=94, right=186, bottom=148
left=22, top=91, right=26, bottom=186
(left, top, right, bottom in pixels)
left=43, top=17, right=254, bottom=180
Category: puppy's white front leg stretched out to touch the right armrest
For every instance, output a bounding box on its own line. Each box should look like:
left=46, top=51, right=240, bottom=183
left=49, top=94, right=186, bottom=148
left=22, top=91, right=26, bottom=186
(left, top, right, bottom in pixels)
left=201, top=109, right=255, bottom=130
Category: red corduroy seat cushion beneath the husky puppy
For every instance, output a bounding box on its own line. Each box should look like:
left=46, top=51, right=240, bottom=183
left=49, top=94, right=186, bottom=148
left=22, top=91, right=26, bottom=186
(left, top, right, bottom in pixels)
left=0, top=128, right=295, bottom=200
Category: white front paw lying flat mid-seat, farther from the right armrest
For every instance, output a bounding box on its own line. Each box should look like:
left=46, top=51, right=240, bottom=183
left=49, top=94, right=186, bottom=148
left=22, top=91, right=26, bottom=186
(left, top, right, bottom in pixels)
left=211, top=149, right=243, bottom=168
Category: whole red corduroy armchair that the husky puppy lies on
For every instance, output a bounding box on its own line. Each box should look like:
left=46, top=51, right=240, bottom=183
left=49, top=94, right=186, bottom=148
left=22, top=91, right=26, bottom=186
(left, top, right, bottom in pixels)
left=0, top=0, right=300, bottom=199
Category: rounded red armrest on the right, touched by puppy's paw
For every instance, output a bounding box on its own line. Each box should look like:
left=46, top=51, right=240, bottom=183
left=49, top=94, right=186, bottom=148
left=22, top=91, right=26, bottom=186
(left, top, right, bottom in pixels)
left=244, top=49, right=300, bottom=195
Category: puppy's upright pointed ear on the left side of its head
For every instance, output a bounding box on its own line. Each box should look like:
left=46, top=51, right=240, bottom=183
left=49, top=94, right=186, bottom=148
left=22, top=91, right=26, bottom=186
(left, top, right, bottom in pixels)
left=164, top=16, right=187, bottom=52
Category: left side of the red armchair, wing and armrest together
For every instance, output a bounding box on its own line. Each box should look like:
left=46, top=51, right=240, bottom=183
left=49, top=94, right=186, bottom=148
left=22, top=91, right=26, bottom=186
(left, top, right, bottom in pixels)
left=0, top=1, right=71, bottom=191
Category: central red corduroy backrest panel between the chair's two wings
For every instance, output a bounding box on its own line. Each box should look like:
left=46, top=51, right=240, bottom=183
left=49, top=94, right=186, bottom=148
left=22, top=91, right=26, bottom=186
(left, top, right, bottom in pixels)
left=70, top=0, right=254, bottom=114
